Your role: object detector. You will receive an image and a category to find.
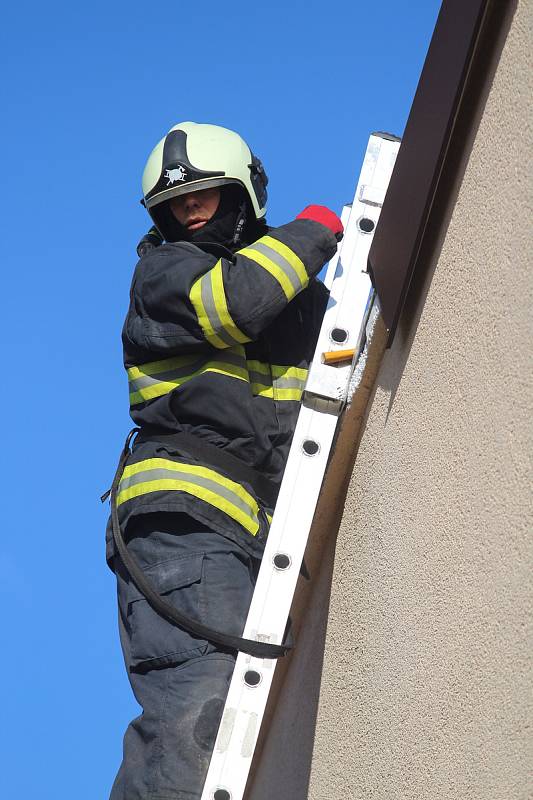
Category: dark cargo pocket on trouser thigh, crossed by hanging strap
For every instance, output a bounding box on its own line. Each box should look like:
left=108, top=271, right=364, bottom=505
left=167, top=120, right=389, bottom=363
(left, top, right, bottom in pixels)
left=128, top=553, right=208, bottom=669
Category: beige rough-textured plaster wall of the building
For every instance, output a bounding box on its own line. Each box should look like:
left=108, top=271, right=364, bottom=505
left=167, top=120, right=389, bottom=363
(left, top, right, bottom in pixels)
left=251, top=2, right=533, bottom=800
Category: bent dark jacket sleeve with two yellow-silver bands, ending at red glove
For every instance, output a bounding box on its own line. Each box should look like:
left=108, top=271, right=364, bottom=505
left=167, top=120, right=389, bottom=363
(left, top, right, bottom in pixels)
left=123, top=219, right=337, bottom=355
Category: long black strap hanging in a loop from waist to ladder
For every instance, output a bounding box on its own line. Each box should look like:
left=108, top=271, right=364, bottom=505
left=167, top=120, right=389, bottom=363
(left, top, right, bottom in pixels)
left=102, top=428, right=291, bottom=659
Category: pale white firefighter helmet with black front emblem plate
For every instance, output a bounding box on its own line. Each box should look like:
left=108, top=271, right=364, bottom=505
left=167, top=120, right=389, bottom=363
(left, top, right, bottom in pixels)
left=141, top=122, right=268, bottom=236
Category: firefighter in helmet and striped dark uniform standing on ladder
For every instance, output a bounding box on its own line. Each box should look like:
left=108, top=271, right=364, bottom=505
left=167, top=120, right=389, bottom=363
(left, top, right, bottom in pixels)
left=107, top=122, right=342, bottom=800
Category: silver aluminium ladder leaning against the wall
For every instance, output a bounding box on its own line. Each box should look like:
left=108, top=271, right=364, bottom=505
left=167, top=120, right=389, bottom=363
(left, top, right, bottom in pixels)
left=202, top=133, right=400, bottom=800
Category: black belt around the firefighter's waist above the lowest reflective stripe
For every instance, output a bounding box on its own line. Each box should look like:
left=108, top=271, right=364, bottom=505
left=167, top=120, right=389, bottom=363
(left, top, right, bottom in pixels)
left=135, top=427, right=279, bottom=508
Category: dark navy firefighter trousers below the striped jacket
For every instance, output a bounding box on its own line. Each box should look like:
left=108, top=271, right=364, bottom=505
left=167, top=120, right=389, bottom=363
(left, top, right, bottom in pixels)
left=110, top=513, right=259, bottom=800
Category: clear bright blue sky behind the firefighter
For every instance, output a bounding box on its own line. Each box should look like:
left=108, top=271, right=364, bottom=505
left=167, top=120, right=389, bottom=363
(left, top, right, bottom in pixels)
left=0, top=0, right=440, bottom=800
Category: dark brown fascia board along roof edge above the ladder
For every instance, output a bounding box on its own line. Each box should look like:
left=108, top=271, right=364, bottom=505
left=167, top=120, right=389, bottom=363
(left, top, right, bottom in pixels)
left=368, top=0, right=490, bottom=347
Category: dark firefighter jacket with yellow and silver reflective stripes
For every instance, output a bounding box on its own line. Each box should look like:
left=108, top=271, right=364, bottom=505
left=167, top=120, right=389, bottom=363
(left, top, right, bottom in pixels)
left=117, top=219, right=337, bottom=555
